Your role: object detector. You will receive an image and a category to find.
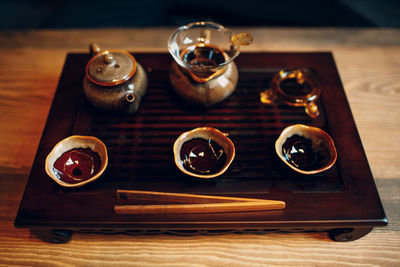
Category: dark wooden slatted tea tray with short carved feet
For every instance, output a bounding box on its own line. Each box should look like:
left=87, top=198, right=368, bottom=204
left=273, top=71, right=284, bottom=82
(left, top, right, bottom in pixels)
left=15, top=53, right=387, bottom=243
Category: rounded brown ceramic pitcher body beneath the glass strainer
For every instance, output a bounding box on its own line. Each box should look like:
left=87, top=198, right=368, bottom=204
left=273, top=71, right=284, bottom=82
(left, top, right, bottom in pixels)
left=169, top=62, right=239, bottom=107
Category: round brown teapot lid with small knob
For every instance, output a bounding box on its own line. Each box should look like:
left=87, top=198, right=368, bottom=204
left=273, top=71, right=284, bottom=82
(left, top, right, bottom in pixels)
left=86, top=50, right=136, bottom=86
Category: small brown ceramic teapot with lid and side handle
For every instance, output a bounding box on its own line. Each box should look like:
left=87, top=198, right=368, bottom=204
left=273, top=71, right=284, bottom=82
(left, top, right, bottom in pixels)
left=83, top=44, right=147, bottom=113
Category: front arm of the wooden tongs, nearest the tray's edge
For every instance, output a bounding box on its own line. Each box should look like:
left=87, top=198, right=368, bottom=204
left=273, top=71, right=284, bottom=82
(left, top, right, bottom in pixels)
left=114, top=200, right=285, bottom=217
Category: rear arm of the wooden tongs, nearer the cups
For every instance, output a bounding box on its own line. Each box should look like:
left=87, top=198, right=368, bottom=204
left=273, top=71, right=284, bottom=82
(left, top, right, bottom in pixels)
left=117, top=189, right=278, bottom=204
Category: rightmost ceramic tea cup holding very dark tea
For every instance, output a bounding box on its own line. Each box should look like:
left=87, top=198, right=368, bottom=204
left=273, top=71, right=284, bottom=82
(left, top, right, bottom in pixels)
left=275, top=124, right=337, bottom=174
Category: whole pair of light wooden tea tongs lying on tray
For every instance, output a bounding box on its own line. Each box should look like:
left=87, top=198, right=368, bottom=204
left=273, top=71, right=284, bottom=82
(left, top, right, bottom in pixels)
left=114, top=190, right=286, bottom=214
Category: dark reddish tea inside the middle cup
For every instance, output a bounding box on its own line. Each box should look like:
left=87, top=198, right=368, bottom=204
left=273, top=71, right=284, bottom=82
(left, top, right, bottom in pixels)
left=180, top=138, right=226, bottom=174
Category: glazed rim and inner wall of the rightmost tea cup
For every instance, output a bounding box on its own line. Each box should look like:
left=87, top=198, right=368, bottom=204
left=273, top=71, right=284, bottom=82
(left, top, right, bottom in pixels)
left=275, top=124, right=337, bottom=175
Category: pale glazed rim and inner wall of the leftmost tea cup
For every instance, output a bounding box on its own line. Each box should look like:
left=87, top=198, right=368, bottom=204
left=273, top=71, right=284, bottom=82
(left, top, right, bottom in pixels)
left=45, top=135, right=108, bottom=187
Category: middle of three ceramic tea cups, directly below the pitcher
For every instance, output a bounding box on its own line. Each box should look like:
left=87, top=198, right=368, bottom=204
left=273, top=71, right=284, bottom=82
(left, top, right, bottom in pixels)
left=173, top=127, right=235, bottom=178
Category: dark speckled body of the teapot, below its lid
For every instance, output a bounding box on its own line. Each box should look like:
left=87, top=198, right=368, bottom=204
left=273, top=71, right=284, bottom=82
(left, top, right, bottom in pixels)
left=83, top=62, right=147, bottom=113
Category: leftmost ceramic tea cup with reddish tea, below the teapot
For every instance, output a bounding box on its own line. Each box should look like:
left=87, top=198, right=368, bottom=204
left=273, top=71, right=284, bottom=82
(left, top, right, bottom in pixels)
left=45, top=135, right=108, bottom=187
